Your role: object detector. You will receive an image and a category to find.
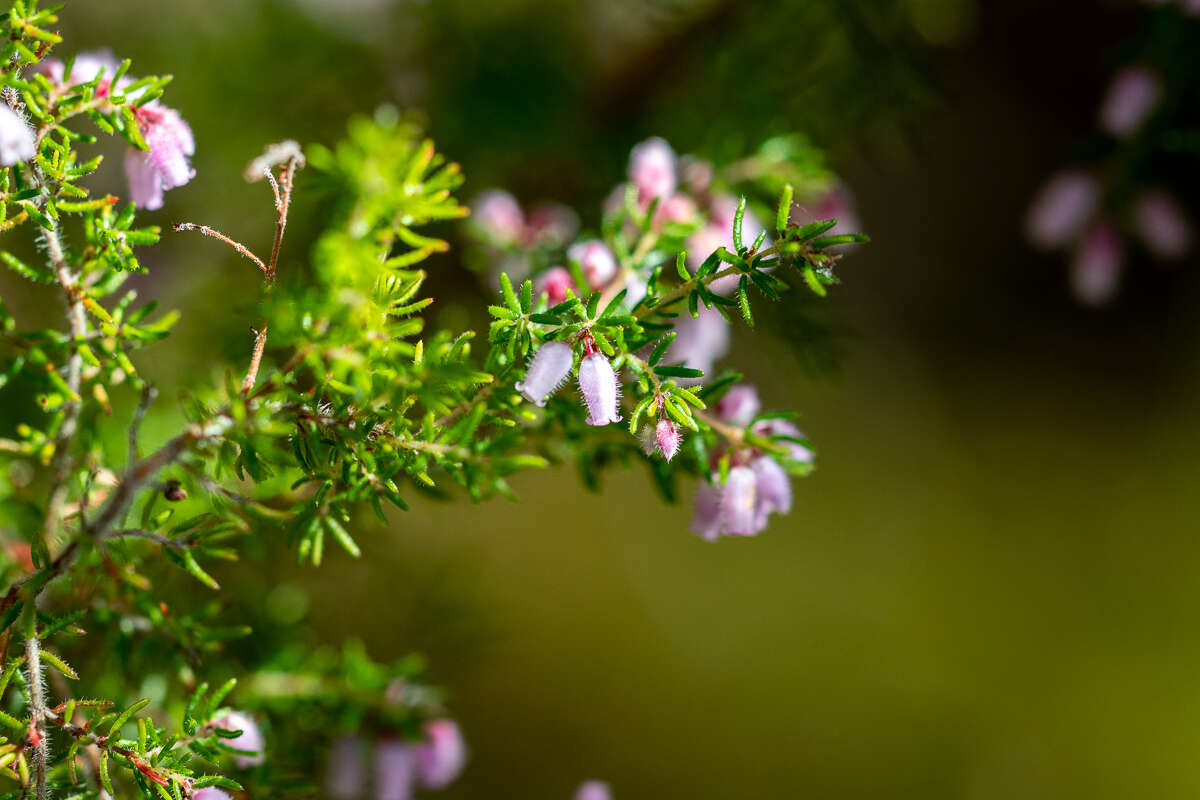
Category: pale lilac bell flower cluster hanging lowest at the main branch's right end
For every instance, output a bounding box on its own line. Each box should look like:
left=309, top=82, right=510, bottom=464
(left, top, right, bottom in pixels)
left=691, top=384, right=812, bottom=541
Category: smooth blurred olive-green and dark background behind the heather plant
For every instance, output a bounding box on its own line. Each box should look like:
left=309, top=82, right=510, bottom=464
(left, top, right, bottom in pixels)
left=11, top=0, right=1200, bottom=800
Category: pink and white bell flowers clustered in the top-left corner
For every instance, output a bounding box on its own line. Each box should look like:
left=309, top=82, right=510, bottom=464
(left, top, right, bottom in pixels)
left=0, top=50, right=196, bottom=211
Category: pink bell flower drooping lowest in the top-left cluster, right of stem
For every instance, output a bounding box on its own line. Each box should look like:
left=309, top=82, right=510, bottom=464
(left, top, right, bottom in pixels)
left=125, top=102, right=196, bottom=211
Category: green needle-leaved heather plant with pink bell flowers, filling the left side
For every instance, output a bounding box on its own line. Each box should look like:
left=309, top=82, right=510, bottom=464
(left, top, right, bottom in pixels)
left=0, top=0, right=865, bottom=800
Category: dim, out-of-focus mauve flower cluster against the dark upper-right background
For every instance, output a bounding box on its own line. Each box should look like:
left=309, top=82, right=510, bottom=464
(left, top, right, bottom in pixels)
left=1026, top=60, right=1200, bottom=306
